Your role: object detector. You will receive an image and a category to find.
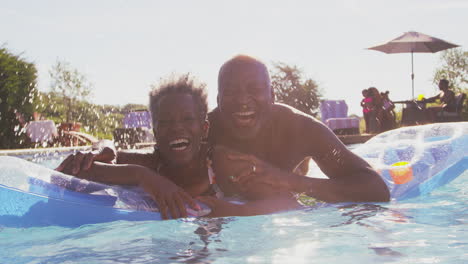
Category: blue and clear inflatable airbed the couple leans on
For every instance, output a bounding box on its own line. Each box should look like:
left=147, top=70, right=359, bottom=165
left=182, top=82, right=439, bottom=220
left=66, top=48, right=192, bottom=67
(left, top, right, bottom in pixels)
left=0, top=122, right=468, bottom=227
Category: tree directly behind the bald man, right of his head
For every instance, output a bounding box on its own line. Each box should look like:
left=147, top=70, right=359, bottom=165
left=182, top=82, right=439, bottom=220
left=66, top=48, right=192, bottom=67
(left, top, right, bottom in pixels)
left=271, top=62, right=321, bottom=116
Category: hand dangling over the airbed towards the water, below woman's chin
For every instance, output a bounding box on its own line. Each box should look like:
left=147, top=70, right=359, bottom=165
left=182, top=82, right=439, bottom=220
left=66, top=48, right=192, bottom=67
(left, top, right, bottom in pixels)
left=140, top=174, right=201, bottom=219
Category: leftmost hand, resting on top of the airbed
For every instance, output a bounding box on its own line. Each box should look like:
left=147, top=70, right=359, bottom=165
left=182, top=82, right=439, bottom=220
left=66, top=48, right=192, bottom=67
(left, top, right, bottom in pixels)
left=55, top=144, right=116, bottom=176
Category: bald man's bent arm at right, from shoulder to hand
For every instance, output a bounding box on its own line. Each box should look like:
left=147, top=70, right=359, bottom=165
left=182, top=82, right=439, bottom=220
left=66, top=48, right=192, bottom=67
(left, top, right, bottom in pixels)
left=221, top=118, right=390, bottom=202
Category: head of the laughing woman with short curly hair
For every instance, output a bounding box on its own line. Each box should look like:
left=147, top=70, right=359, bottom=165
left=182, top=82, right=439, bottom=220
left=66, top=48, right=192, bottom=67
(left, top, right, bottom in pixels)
left=150, top=75, right=209, bottom=166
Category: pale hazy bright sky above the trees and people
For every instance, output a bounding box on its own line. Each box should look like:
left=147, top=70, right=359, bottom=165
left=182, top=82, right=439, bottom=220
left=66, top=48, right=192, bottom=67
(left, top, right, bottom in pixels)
left=0, top=0, right=468, bottom=115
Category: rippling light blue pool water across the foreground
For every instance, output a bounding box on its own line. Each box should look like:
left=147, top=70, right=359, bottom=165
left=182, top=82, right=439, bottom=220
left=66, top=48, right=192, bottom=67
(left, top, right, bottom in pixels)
left=0, top=153, right=468, bottom=264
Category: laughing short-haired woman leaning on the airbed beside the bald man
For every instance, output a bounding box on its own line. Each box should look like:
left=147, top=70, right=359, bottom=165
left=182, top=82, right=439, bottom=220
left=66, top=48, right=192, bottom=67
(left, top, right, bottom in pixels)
left=65, top=74, right=216, bottom=218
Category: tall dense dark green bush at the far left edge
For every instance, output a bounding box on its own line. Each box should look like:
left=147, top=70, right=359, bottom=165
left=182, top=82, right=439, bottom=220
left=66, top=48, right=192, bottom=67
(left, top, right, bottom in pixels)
left=0, top=47, right=37, bottom=149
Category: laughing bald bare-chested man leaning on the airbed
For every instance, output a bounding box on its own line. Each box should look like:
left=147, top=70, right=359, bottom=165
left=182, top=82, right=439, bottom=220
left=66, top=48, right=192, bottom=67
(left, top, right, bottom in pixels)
left=208, top=55, right=389, bottom=202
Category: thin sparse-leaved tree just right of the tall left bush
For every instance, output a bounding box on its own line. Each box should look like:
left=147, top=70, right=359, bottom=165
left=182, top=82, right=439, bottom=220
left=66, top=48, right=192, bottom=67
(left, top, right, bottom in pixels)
left=49, top=61, right=92, bottom=123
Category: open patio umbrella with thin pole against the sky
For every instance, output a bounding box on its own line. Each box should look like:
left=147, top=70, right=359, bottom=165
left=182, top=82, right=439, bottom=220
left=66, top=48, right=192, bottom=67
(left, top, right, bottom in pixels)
left=368, top=31, right=458, bottom=98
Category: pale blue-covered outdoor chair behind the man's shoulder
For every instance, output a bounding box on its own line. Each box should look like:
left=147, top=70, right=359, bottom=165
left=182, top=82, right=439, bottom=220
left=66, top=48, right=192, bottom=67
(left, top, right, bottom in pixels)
left=320, top=100, right=359, bottom=135
